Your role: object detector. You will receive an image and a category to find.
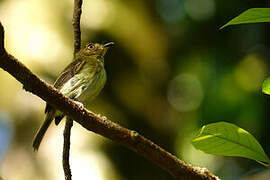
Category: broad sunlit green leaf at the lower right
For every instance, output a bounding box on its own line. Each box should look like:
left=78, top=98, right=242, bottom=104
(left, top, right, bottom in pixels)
left=192, top=122, right=270, bottom=166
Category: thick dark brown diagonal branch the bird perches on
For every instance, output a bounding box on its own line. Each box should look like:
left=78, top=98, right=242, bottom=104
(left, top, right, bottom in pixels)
left=0, top=24, right=219, bottom=180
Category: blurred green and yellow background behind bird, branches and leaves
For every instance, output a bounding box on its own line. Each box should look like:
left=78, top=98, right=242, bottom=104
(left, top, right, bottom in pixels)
left=0, top=0, right=270, bottom=180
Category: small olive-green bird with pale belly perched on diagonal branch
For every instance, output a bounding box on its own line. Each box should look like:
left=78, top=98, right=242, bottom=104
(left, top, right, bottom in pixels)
left=33, top=42, right=114, bottom=151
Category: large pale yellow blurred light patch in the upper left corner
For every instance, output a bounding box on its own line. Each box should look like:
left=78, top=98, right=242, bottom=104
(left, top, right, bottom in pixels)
left=0, top=0, right=68, bottom=62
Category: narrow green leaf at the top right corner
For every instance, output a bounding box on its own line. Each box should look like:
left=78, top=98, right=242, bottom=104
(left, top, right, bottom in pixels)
left=220, top=8, right=270, bottom=29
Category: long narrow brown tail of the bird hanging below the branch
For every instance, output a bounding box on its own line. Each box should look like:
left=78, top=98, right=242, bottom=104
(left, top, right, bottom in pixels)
left=33, top=110, right=54, bottom=151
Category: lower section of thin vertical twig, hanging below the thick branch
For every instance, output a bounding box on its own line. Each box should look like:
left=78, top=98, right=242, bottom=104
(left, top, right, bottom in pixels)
left=63, top=118, right=73, bottom=180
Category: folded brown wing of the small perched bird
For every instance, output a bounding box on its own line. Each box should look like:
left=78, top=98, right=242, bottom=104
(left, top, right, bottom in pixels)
left=45, top=59, right=85, bottom=113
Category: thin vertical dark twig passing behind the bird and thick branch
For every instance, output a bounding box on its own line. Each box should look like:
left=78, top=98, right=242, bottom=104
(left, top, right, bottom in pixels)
left=63, top=0, right=82, bottom=180
